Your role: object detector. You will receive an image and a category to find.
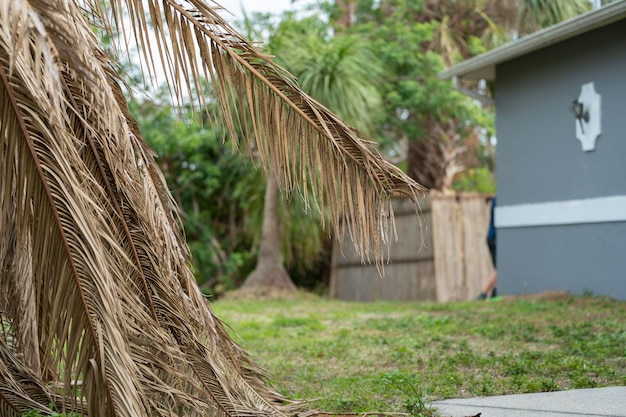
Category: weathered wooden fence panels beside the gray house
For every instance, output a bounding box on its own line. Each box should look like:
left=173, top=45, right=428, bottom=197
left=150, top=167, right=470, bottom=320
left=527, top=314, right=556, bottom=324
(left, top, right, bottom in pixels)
left=330, top=192, right=493, bottom=301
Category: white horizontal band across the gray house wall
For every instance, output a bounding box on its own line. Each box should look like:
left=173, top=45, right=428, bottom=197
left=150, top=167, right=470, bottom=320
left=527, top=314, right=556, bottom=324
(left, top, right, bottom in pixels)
left=494, top=195, right=626, bottom=228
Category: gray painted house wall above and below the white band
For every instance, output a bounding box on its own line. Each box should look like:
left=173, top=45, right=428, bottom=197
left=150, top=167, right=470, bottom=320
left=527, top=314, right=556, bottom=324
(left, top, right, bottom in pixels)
left=496, top=21, right=626, bottom=299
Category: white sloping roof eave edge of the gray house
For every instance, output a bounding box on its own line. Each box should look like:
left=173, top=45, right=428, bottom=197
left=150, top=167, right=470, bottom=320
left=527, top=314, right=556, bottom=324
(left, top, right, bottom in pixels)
left=439, top=1, right=626, bottom=80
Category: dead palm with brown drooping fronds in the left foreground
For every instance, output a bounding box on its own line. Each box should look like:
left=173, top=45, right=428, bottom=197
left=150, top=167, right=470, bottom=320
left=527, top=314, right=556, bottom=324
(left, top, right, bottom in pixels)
left=0, top=0, right=420, bottom=416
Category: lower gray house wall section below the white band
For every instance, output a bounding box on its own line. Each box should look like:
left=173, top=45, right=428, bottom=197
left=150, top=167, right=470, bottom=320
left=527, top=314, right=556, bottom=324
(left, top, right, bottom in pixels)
left=498, top=222, right=626, bottom=300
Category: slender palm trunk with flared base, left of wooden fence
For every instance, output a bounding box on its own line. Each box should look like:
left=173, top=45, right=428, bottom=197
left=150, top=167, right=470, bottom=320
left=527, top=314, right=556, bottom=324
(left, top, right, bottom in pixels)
left=242, top=173, right=296, bottom=291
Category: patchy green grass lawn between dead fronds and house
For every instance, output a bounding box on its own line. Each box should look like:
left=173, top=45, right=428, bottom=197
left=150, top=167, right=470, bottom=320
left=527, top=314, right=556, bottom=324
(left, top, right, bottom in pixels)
left=212, top=294, right=626, bottom=415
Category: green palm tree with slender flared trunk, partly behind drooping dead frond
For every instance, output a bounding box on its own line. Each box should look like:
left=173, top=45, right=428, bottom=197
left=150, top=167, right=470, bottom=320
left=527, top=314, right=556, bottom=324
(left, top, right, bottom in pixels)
left=243, top=17, right=381, bottom=291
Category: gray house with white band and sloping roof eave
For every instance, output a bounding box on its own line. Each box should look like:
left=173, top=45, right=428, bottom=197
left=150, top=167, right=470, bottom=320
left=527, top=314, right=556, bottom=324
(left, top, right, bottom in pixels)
left=441, top=1, right=626, bottom=299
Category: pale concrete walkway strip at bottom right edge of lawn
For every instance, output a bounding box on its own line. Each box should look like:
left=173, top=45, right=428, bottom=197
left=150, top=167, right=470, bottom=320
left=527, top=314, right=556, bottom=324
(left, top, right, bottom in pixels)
left=430, top=387, right=626, bottom=417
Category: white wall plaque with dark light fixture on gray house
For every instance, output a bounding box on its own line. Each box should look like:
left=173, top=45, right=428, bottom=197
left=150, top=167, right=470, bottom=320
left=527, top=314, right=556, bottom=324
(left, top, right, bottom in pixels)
left=570, top=82, right=602, bottom=152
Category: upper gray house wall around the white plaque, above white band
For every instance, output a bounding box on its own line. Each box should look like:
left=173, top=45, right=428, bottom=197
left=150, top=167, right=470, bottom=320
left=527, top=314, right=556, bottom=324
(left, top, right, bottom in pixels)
left=496, top=22, right=626, bottom=205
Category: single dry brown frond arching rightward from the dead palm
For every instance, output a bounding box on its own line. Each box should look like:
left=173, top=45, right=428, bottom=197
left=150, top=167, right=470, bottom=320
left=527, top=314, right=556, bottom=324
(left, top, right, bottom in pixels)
left=94, top=0, right=422, bottom=260
